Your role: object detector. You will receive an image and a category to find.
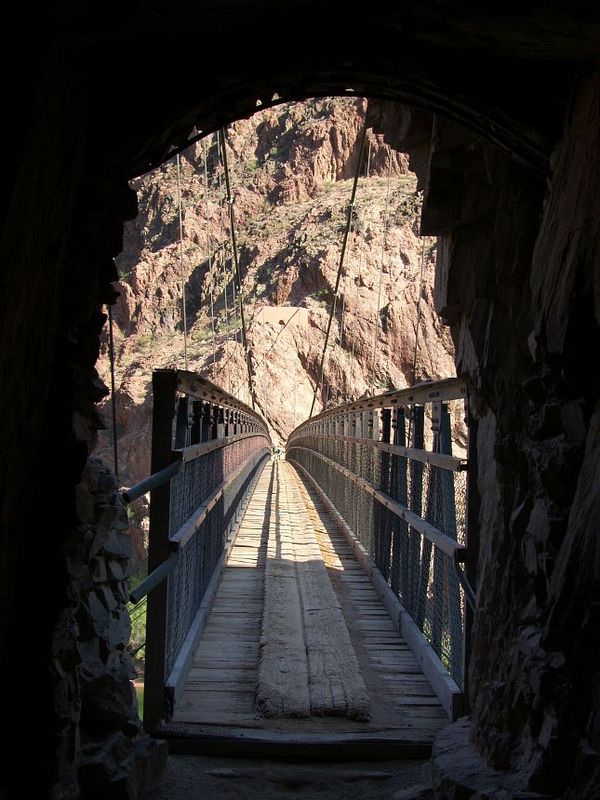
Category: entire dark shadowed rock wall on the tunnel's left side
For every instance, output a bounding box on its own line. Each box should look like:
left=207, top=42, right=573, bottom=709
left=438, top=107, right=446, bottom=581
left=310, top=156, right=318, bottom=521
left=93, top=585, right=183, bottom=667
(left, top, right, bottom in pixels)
left=0, top=79, right=164, bottom=788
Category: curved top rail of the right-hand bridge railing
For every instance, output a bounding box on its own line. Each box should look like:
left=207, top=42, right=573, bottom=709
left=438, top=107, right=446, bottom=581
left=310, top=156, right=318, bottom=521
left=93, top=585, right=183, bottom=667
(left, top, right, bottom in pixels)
left=288, top=378, right=467, bottom=441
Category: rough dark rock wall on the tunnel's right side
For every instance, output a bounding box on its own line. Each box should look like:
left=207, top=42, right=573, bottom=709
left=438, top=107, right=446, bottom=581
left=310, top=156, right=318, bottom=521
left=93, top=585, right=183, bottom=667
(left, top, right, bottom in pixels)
left=373, top=70, right=600, bottom=798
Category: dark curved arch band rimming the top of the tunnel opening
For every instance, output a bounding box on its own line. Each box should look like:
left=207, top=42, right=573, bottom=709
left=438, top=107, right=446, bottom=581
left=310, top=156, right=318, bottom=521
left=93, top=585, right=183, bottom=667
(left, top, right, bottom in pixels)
left=104, top=54, right=557, bottom=182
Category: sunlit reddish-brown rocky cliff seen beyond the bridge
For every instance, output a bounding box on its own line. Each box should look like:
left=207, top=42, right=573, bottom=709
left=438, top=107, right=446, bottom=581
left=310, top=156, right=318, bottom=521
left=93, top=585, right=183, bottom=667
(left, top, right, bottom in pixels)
left=96, top=98, right=464, bottom=776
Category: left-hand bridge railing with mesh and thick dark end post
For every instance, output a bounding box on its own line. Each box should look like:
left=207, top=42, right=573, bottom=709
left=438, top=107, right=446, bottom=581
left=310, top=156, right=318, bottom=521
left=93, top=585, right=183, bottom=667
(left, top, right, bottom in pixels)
left=124, top=370, right=271, bottom=729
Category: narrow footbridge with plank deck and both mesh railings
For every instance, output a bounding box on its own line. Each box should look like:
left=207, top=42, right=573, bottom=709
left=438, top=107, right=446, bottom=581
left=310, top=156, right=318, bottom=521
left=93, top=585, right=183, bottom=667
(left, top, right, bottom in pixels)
left=125, top=370, right=473, bottom=757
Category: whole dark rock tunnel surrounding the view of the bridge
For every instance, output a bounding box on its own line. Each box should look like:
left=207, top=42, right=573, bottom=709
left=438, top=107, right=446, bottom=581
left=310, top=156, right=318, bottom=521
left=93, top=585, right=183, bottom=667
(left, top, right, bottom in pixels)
left=0, top=0, right=600, bottom=800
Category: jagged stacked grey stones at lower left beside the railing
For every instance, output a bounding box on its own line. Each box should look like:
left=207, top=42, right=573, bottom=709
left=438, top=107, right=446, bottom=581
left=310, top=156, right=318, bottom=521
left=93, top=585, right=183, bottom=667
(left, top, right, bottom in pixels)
left=72, top=459, right=167, bottom=800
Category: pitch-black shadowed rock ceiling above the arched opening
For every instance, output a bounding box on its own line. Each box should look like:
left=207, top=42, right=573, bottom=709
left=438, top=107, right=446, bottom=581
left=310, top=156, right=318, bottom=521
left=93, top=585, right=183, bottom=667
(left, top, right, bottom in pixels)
left=45, top=0, right=600, bottom=177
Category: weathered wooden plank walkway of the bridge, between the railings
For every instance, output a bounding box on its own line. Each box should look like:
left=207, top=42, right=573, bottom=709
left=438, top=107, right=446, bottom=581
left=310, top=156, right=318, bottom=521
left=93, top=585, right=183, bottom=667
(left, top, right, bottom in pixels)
left=165, top=462, right=448, bottom=755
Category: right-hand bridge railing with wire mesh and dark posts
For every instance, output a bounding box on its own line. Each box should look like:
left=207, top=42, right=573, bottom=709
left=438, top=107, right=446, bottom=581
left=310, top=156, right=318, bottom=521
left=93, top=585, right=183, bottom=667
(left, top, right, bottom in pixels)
left=286, top=379, right=474, bottom=717
